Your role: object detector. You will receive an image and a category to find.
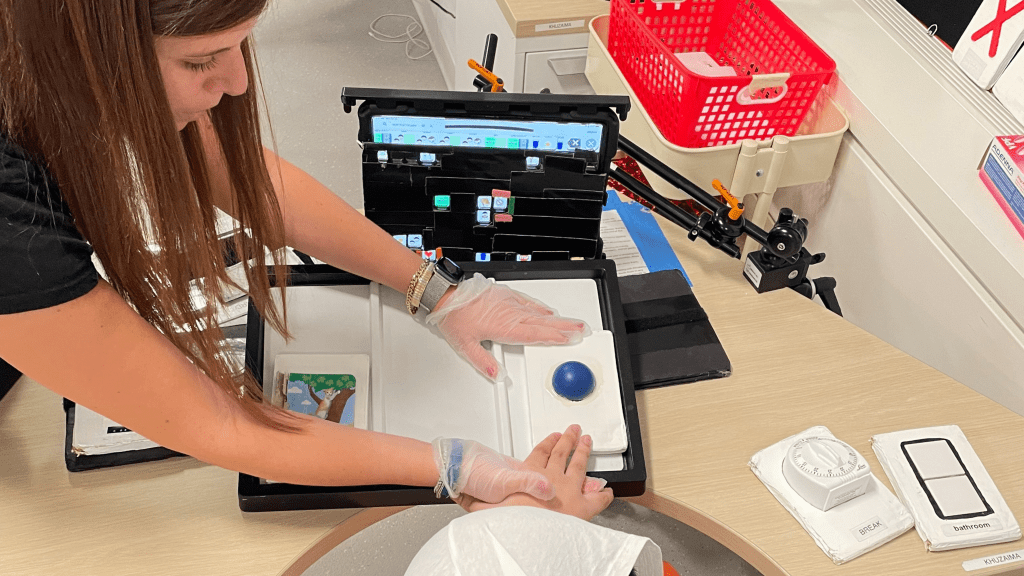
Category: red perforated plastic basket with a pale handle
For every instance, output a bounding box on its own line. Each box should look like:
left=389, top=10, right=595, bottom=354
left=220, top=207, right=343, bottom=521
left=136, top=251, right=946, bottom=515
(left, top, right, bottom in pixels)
left=608, top=0, right=836, bottom=148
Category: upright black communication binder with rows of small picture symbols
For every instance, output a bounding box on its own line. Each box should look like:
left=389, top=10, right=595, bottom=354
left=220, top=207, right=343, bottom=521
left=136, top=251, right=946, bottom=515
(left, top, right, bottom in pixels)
left=341, top=87, right=630, bottom=261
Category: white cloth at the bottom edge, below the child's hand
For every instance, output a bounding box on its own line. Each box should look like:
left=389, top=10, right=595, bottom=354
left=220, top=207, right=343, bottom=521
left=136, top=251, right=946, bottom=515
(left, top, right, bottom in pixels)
left=406, top=506, right=664, bottom=576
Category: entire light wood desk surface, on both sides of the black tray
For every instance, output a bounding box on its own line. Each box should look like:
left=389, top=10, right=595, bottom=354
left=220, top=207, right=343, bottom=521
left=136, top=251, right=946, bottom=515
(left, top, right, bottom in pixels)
left=0, top=212, right=1024, bottom=576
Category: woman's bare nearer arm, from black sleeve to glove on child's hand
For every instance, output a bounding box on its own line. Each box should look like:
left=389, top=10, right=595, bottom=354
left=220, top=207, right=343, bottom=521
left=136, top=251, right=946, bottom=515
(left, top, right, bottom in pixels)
left=0, top=282, right=437, bottom=486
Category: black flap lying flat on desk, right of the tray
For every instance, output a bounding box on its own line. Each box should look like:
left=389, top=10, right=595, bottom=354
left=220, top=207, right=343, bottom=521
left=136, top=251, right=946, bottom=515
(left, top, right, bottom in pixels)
left=618, top=270, right=732, bottom=388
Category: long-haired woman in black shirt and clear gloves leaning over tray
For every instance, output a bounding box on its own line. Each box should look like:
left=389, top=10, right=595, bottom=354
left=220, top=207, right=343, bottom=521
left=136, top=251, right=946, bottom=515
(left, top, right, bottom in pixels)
left=0, top=0, right=598, bottom=501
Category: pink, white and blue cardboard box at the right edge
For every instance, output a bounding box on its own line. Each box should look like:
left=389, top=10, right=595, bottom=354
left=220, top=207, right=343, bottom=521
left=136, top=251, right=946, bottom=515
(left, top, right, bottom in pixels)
left=978, top=135, right=1024, bottom=238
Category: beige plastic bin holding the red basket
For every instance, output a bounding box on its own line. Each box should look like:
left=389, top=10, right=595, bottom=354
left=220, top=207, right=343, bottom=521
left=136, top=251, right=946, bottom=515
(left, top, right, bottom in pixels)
left=586, top=15, right=850, bottom=230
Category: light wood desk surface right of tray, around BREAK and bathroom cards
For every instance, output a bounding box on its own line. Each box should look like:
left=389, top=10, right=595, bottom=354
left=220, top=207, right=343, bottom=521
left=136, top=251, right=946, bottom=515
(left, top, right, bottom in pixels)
left=638, top=214, right=1024, bottom=576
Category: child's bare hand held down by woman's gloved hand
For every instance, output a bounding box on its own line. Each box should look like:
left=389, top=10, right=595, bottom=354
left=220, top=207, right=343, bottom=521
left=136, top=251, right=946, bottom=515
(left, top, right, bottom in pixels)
left=458, top=424, right=614, bottom=520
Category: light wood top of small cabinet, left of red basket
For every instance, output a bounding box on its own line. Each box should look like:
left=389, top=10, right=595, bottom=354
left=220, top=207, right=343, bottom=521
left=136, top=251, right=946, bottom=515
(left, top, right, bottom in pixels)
left=489, top=0, right=608, bottom=38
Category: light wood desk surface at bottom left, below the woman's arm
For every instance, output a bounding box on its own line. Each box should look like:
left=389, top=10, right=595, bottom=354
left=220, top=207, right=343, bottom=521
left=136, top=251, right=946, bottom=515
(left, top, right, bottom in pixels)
left=0, top=378, right=355, bottom=576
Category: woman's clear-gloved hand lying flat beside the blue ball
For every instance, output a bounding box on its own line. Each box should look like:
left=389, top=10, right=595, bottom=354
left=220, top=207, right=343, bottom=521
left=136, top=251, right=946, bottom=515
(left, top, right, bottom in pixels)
left=426, top=274, right=590, bottom=381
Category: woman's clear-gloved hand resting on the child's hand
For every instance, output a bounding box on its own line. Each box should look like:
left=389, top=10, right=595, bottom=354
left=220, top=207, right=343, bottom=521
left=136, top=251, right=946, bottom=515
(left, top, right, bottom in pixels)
left=431, top=438, right=555, bottom=502
